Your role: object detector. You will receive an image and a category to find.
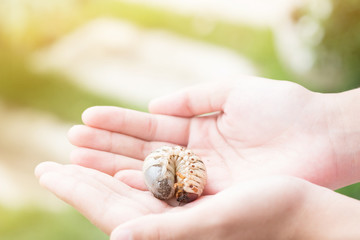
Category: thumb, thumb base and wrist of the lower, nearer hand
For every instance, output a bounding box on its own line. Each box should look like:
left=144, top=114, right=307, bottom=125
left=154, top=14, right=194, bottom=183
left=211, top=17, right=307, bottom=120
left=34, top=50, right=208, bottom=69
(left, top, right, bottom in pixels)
left=110, top=176, right=360, bottom=240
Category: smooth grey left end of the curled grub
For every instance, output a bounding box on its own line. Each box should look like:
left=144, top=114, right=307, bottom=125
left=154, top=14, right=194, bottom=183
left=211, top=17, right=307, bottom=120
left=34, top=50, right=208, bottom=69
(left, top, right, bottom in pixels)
left=144, top=165, right=175, bottom=200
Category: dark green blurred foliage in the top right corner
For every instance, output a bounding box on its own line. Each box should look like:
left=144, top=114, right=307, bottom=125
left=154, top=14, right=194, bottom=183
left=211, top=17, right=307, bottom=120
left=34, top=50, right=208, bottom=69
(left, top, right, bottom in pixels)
left=316, top=0, right=360, bottom=91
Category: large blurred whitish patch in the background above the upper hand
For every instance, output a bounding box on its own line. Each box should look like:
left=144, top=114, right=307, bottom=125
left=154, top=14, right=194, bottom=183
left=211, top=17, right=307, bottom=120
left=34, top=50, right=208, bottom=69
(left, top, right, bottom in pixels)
left=35, top=18, right=256, bottom=105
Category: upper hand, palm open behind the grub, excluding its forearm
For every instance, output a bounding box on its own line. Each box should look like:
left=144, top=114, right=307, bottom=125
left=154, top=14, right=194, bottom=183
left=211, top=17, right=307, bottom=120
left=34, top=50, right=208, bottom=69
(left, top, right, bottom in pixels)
left=69, top=77, right=348, bottom=194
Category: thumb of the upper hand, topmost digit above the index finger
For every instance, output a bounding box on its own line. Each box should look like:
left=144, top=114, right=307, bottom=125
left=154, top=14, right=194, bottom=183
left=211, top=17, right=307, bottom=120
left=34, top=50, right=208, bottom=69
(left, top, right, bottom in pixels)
left=149, top=82, right=233, bottom=117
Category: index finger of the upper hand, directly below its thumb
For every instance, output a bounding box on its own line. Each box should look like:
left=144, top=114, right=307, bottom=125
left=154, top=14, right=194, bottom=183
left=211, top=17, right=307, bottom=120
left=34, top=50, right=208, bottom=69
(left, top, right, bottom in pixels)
left=82, top=107, right=190, bottom=145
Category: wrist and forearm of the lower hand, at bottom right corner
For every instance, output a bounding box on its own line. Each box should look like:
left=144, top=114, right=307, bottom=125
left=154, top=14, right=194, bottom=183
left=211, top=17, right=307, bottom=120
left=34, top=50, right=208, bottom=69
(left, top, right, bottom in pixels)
left=294, top=186, right=360, bottom=240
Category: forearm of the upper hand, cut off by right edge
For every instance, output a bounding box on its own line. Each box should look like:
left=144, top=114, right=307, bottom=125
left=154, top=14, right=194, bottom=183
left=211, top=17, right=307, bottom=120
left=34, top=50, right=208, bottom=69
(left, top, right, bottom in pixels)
left=323, top=89, right=360, bottom=186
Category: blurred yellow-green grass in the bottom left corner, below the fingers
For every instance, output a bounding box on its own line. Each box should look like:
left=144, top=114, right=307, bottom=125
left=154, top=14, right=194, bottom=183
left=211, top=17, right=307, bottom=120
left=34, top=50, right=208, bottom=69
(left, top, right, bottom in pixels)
left=0, top=204, right=108, bottom=240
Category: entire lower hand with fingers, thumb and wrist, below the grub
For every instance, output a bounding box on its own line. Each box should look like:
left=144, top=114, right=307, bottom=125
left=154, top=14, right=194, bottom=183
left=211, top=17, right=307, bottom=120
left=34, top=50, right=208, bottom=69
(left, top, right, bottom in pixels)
left=35, top=163, right=360, bottom=240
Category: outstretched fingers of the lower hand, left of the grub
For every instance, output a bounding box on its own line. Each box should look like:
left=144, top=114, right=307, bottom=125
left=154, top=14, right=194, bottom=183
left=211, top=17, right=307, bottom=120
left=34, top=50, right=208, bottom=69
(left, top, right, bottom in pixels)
left=35, top=163, right=168, bottom=234
